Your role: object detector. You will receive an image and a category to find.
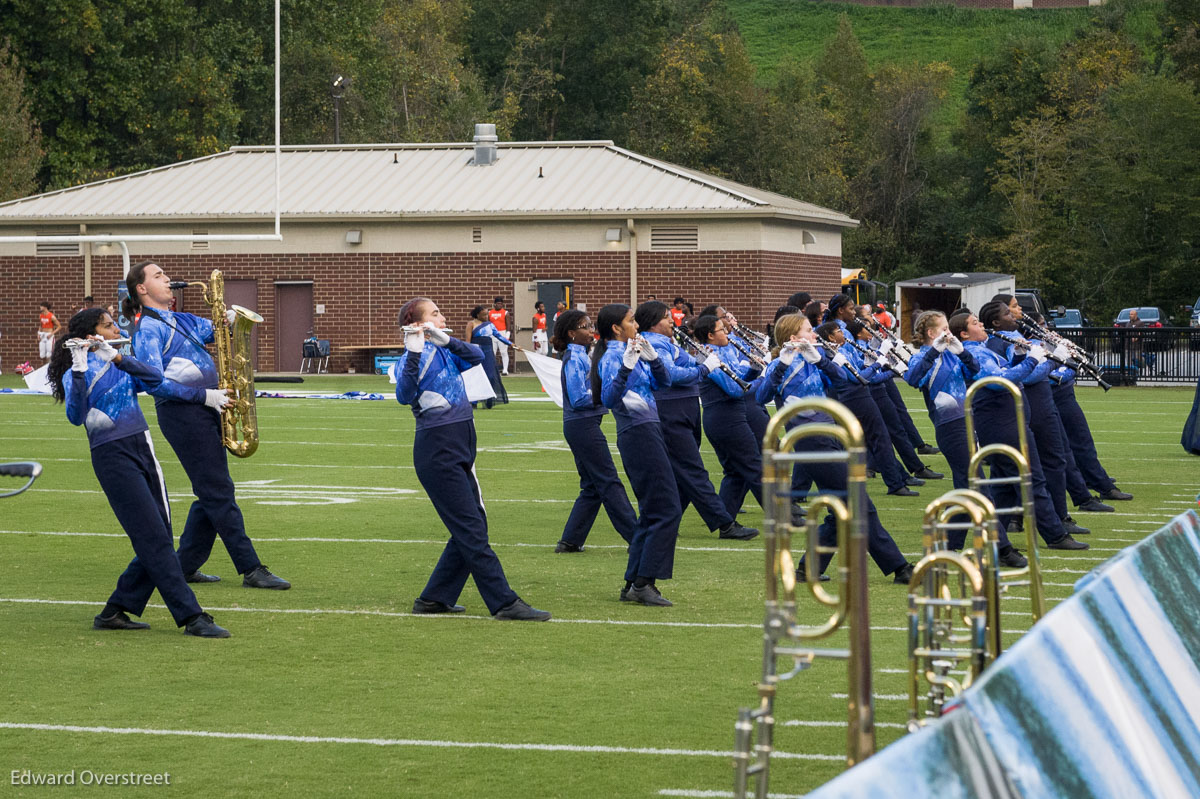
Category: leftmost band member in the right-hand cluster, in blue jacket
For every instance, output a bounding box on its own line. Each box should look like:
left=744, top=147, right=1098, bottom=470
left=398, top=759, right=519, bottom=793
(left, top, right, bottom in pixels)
left=550, top=311, right=637, bottom=552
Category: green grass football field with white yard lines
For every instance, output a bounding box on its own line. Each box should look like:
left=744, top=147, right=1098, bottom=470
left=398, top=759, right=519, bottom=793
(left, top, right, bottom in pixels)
left=0, top=376, right=1200, bottom=798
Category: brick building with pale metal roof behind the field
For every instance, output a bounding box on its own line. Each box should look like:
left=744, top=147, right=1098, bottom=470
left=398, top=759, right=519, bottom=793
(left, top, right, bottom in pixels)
left=0, top=131, right=857, bottom=372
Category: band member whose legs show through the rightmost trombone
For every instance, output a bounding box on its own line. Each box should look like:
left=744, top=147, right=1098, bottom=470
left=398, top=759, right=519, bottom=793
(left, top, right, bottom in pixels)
left=950, top=304, right=1087, bottom=549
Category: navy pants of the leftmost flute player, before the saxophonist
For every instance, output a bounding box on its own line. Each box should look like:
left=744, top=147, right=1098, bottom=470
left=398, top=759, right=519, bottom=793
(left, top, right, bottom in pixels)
left=91, top=432, right=200, bottom=626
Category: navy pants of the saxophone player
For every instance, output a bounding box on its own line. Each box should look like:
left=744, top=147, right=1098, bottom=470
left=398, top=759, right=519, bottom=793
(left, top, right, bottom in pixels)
left=156, top=402, right=262, bottom=575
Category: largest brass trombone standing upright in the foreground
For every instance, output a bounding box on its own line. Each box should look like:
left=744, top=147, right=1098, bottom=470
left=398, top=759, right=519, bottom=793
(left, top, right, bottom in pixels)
left=733, top=397, right=875, bottom=799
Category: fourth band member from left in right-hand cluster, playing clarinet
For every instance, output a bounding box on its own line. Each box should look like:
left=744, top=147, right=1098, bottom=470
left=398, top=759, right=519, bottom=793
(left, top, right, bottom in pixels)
left=692, top=314, right=762, bottom=516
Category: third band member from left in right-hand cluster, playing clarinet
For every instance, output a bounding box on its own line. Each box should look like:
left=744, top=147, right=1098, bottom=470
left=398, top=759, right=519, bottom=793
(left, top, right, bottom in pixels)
left=634, top=301, right=758, bottom=541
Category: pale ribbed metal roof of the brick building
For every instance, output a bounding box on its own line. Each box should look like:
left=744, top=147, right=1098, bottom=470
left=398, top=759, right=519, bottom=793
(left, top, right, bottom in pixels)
left=0, top=142, right=858, bottom=227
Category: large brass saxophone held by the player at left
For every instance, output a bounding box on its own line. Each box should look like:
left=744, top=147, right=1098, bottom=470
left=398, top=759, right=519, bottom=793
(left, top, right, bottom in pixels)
left=188, top=269, right=263, bottom=458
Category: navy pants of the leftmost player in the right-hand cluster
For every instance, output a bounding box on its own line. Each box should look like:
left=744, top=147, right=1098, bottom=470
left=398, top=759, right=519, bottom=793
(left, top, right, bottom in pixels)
left=562, top=416, right=637, bottom=546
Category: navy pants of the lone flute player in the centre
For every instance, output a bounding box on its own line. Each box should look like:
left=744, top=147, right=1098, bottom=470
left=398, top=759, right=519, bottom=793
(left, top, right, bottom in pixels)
left=413, top=419, right=520, bottom=613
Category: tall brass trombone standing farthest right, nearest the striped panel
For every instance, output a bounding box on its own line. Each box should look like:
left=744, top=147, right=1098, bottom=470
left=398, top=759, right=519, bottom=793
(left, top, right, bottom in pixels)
left=964, top=376, right=1046, bottom=623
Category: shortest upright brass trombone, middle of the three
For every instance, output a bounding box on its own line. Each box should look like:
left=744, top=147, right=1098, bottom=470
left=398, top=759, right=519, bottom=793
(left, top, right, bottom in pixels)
left=908, top=489, right=1001, bottom=732
